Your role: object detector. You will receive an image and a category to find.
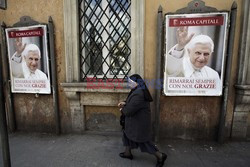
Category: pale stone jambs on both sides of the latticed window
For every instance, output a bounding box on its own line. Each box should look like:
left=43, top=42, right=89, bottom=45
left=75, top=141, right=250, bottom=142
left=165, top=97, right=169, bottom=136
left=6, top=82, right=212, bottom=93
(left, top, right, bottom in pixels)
left=63, top=0, right=145, bottom=83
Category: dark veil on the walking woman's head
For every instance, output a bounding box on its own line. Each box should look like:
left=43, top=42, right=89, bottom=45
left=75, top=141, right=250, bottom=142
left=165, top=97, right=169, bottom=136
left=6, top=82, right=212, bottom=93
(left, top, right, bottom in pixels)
left=128, top=74, right=153, bottom=102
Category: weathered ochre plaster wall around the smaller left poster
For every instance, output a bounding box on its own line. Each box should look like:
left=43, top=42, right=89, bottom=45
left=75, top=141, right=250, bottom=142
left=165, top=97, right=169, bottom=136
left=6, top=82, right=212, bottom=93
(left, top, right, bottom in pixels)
left=0, top=0, right=71, bottom=132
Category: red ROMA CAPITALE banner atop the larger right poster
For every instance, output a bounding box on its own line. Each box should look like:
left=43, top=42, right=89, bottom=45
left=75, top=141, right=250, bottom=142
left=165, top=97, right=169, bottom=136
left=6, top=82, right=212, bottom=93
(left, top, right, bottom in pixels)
left=169, top=16, right=224, bottom=27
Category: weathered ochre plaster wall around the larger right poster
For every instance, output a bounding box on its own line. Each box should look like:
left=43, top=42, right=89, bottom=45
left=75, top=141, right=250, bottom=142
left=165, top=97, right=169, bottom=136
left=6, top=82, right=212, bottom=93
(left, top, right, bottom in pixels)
left=144, top=0, right=242, bottom=139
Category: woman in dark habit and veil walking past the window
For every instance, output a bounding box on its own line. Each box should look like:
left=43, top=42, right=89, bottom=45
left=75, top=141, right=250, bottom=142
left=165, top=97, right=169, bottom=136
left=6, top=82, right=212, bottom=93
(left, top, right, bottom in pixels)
left=118, top=74, right=167, bottom=167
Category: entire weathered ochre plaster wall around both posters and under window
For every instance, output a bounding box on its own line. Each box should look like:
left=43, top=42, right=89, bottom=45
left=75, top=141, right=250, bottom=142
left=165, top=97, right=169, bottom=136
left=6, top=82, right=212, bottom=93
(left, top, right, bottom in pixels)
left=0, top=0, right=245, bottom=139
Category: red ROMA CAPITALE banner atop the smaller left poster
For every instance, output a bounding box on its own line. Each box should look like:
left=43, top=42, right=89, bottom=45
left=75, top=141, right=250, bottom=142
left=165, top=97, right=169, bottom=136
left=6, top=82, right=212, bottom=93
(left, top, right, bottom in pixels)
left=8, top=28, right=43, bottom=38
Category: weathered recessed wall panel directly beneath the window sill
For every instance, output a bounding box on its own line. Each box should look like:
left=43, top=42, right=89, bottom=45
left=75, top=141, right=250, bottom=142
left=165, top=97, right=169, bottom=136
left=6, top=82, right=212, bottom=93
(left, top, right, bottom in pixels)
left=81, top=92, right=127, bottom=132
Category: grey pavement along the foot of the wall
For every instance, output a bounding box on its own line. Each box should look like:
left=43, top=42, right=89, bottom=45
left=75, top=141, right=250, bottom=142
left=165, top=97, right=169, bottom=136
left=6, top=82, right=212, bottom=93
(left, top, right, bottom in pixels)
left=0, top=133, right=250, bottom=167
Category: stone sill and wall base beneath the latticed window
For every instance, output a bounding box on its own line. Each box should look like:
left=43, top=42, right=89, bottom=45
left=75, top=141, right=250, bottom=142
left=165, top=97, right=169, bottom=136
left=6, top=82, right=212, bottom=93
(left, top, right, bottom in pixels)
left=62, top=83, right=129, bottom=133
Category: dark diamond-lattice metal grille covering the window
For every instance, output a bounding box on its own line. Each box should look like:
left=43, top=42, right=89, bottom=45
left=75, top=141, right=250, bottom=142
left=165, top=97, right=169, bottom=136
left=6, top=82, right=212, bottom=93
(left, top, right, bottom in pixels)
left=79, top=0, right=131, bottom=81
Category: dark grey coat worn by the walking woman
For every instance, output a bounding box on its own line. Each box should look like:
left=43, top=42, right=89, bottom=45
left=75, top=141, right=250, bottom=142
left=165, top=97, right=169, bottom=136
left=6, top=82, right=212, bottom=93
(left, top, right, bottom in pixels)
left=122, top=88, right=151, bottom=142
